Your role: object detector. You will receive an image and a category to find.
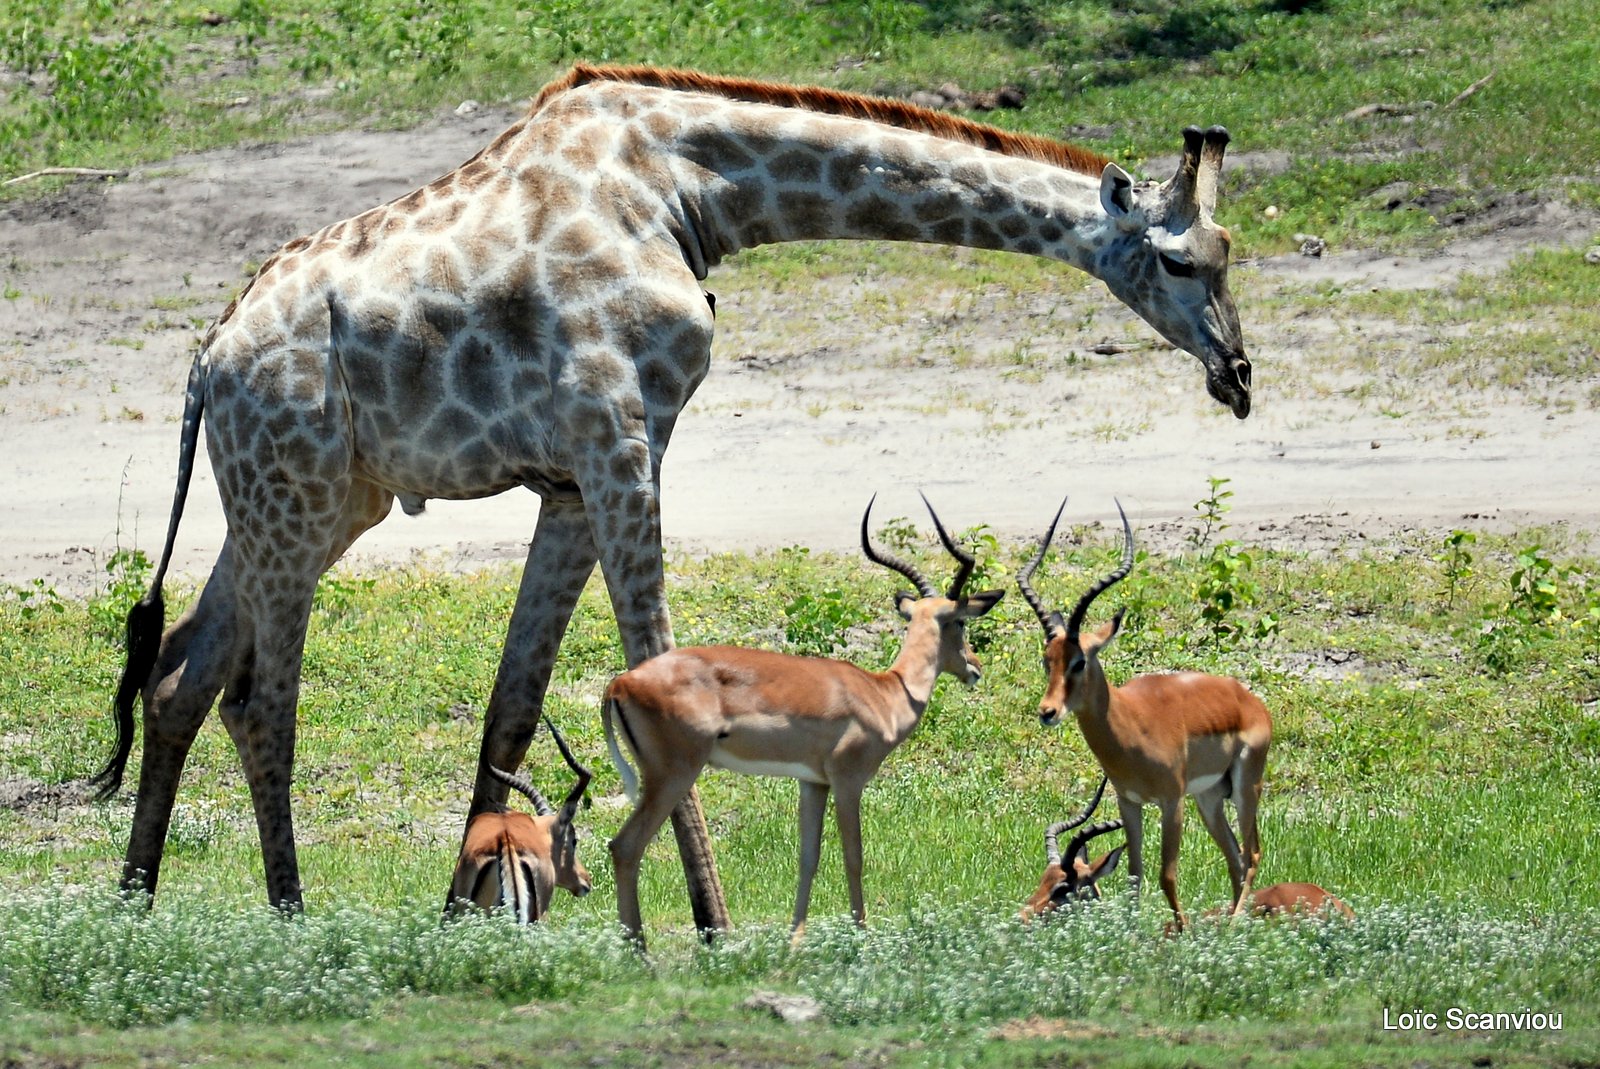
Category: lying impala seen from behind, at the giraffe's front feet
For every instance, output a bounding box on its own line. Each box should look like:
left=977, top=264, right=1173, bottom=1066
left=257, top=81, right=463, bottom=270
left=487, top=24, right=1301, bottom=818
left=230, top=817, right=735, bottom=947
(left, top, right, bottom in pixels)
left=450, top=717, right=590, bottom=925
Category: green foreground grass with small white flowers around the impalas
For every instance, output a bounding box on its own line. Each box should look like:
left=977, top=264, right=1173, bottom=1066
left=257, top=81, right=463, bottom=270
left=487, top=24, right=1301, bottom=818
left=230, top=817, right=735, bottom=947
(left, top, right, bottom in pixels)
left=0, top=512, right=1600, bottom=1064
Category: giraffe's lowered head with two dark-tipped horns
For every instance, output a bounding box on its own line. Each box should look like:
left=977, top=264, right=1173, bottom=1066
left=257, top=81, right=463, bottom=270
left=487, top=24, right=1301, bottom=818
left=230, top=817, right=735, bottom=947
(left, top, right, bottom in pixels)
left=1096, top=126, right=1250, bottom=419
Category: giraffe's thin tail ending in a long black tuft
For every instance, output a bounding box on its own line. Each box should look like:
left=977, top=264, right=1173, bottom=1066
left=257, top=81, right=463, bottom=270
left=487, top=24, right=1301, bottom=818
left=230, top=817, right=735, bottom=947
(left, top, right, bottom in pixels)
left=90, top=346, right=206, bottom=802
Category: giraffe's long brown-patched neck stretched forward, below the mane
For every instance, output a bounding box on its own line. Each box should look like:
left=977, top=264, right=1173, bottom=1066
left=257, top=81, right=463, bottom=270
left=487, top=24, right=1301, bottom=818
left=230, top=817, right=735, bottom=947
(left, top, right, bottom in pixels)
left=502, top=83, right=1114, bottom=277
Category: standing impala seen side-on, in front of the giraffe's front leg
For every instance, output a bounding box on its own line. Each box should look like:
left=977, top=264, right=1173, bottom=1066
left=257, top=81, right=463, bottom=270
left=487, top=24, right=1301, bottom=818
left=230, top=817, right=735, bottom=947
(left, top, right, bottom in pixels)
left=602, top=498, right=1005, bottom=946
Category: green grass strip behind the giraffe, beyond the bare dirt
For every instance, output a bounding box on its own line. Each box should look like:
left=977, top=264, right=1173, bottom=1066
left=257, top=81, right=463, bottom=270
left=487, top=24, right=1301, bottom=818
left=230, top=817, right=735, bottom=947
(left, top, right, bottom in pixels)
left=0, top=0, right=1600, bottom=254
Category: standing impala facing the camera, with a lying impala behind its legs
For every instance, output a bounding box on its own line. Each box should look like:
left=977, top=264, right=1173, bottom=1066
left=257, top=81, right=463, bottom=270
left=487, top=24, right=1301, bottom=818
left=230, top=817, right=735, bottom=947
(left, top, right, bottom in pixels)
left=1018, top=501, right=1272, bottom=931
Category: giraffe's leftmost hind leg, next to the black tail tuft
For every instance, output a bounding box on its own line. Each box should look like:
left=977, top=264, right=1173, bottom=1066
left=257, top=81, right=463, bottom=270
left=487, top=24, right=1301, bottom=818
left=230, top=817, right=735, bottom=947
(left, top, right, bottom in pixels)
left=122, top=539, right=248, bottom=895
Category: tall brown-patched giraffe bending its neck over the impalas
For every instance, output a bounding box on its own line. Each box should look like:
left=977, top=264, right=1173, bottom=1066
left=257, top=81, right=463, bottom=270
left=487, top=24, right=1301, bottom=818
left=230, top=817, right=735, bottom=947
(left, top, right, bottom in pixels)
left=94, top=64, right=1250, bottom=930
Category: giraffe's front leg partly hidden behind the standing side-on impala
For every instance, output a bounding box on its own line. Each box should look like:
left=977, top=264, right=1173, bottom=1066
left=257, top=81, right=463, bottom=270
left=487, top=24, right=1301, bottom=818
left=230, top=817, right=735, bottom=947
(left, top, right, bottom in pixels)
left=584, top=437, right=728, bottom=939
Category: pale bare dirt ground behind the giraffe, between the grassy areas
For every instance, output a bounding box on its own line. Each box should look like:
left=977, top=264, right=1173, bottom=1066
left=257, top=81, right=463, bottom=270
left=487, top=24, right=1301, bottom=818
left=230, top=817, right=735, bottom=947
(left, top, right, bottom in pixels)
left=0, top=110, right=1600, bottom=592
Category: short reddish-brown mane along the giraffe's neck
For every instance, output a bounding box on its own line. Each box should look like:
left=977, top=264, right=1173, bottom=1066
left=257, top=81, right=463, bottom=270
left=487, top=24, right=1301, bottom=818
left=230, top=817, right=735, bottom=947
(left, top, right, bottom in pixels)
left=531, top=62, right=1110, bottom=178
